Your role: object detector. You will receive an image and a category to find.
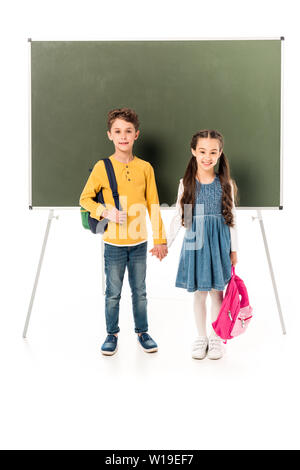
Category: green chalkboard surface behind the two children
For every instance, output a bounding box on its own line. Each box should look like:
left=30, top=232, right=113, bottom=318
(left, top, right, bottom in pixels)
left=29, top=39, right=282, bottom=208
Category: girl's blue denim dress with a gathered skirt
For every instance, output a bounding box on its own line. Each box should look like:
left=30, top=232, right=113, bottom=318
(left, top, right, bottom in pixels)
left=175, top=175, right=231, bottom=292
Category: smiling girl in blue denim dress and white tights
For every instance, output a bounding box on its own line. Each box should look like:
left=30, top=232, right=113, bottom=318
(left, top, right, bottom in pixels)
left=167, top=129, right=237, bottom=359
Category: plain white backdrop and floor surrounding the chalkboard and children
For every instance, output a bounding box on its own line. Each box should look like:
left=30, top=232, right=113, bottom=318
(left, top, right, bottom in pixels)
left=0, top=0, right=300, bottom=449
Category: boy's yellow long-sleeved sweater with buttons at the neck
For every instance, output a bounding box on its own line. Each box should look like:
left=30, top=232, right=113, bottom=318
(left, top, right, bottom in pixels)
left=79, top=155, right=167, bottom=245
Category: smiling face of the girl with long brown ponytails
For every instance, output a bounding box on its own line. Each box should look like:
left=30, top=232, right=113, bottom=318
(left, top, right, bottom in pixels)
left=191, top=138, right=223, bottom=171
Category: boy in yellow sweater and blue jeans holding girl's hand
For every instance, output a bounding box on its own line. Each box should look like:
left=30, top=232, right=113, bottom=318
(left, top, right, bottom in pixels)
left=79, top=108, right=168, bottom=356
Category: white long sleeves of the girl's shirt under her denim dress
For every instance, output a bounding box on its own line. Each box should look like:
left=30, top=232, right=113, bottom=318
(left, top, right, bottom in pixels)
left=167, top=178, right=238, bottom=251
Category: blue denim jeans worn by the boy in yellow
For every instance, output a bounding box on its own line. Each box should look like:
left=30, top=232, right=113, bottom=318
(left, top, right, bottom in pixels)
left=104, top=242, right=148, bottom=334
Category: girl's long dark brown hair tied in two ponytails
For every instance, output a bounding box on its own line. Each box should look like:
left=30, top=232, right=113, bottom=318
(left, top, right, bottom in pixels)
left=180, top=129, right=237, bottom=227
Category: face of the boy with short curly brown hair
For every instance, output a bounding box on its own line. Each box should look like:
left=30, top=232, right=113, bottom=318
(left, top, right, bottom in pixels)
left=107, top=119, right=140, bottom=153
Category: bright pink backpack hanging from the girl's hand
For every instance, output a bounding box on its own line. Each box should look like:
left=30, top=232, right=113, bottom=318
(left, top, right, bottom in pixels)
left=212, top=266, right=253, bottom=343
